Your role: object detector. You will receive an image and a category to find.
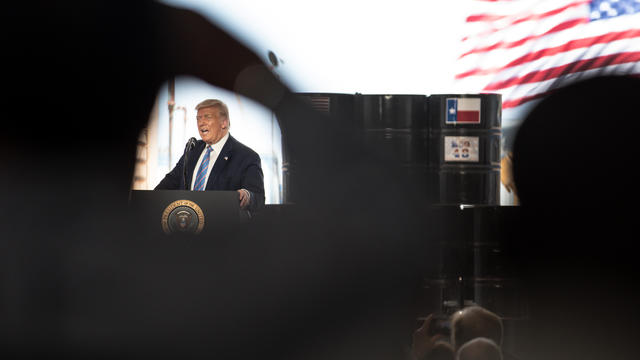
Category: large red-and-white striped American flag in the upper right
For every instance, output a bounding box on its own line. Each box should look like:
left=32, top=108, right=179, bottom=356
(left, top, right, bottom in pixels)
left=455, top=0, right=640, bottom=119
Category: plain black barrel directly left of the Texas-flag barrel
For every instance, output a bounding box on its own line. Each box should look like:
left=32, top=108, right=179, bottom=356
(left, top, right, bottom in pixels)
left=355, top=94, right=429, bottom=186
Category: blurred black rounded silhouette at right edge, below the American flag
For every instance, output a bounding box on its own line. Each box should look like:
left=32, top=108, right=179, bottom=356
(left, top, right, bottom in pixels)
left=508, top=76, right=640, bottom=360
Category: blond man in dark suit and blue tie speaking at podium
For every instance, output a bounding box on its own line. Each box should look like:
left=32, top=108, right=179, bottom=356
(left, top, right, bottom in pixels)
left=155, top=99, right=264, bottom=212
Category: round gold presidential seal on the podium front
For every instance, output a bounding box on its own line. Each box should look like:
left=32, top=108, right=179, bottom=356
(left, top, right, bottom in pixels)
left=162, top=200, right=204, bottom=235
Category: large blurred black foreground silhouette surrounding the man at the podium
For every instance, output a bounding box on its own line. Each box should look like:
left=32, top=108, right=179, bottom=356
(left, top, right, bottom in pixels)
left=0, top=1, right=429, bottom=360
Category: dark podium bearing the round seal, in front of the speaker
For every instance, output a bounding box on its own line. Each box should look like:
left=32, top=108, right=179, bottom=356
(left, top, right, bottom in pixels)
left=129, top=190, right=242, bottom=236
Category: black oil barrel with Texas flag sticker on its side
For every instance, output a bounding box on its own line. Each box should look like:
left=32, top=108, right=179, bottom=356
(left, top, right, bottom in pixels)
left=428, top=94, right=502, bottom=205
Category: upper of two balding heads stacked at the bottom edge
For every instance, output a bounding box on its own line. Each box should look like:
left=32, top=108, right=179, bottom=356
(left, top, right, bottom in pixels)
left=451, top=306, right=502, bottom=349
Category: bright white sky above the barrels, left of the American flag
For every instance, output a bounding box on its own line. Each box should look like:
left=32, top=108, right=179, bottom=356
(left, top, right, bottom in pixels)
left=165, top=0, right=464, bottom=95
